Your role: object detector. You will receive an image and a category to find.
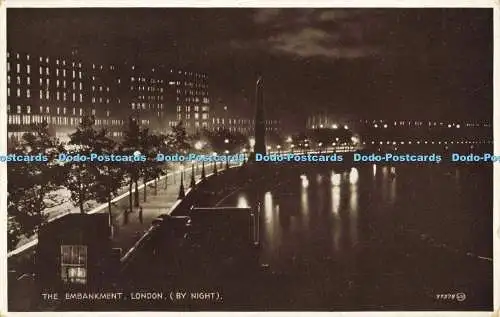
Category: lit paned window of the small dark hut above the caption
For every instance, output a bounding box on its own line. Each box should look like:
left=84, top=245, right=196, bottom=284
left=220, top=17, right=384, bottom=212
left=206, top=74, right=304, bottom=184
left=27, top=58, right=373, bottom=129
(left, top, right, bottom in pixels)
left=61, top=245, right=87, bottom=284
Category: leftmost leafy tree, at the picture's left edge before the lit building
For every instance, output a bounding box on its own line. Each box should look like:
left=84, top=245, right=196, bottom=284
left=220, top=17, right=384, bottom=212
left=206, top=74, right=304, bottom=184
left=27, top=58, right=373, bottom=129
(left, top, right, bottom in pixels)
left=7, top=122, right=65, bottom=250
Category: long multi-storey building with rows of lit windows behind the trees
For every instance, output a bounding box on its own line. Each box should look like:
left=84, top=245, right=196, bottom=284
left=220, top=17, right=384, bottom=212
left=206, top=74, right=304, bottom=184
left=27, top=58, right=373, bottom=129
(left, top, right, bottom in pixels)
left=7, top=51, right=210, bottom=140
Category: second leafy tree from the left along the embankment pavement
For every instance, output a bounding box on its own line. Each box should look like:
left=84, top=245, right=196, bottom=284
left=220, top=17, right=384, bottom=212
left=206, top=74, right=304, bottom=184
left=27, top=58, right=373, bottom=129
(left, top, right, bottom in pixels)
left=64, top=116, right=114, bottom=214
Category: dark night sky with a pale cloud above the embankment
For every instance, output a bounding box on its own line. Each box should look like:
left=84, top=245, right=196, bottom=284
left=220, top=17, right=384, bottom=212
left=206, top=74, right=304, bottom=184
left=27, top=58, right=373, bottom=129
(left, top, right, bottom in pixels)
left=7, top=8, right=493, bottom=128
